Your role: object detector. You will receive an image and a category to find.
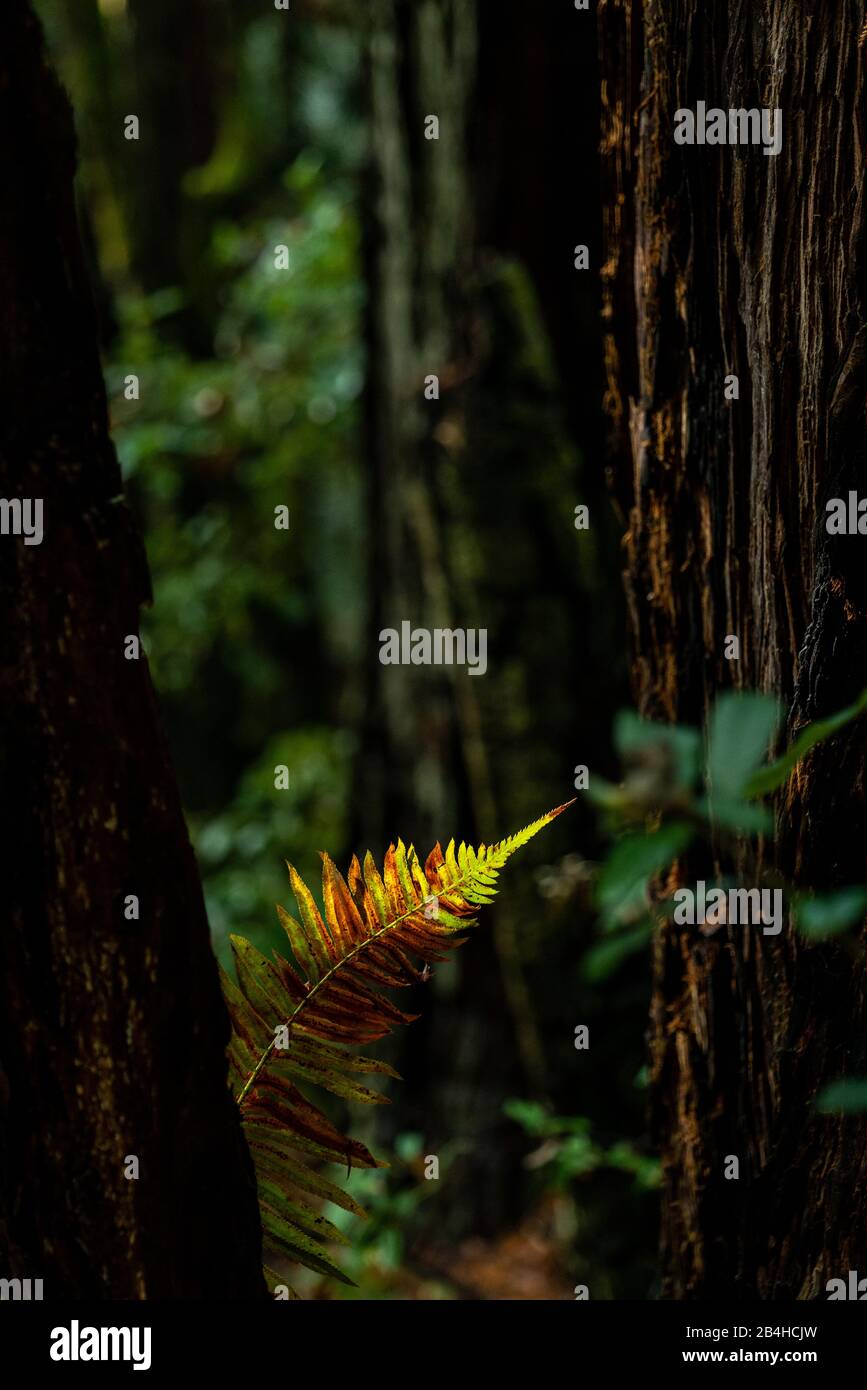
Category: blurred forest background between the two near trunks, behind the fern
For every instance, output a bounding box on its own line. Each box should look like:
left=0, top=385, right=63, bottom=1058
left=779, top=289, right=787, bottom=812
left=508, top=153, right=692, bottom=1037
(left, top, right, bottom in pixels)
left=38, top=0, right=657, bottom=1298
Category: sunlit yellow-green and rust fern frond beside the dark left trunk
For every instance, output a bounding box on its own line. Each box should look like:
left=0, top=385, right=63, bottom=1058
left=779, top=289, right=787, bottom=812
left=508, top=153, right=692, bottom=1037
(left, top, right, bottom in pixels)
left=221, top=802, right=571, bottom=1287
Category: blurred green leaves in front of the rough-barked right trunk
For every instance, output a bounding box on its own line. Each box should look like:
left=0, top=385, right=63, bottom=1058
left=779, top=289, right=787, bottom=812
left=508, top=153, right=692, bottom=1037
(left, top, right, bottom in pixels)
left=584, top=691, right=867, bottom=1113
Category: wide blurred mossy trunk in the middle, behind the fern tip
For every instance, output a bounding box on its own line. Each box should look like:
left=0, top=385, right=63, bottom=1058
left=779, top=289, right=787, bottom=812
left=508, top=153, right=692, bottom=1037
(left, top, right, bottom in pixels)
left=353, top=0, right=617, bottom=1238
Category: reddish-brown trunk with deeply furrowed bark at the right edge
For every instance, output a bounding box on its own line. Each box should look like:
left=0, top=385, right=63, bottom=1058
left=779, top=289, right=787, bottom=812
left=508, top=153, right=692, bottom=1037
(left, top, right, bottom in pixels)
left=599, top=0, right=867, bottom=1298
